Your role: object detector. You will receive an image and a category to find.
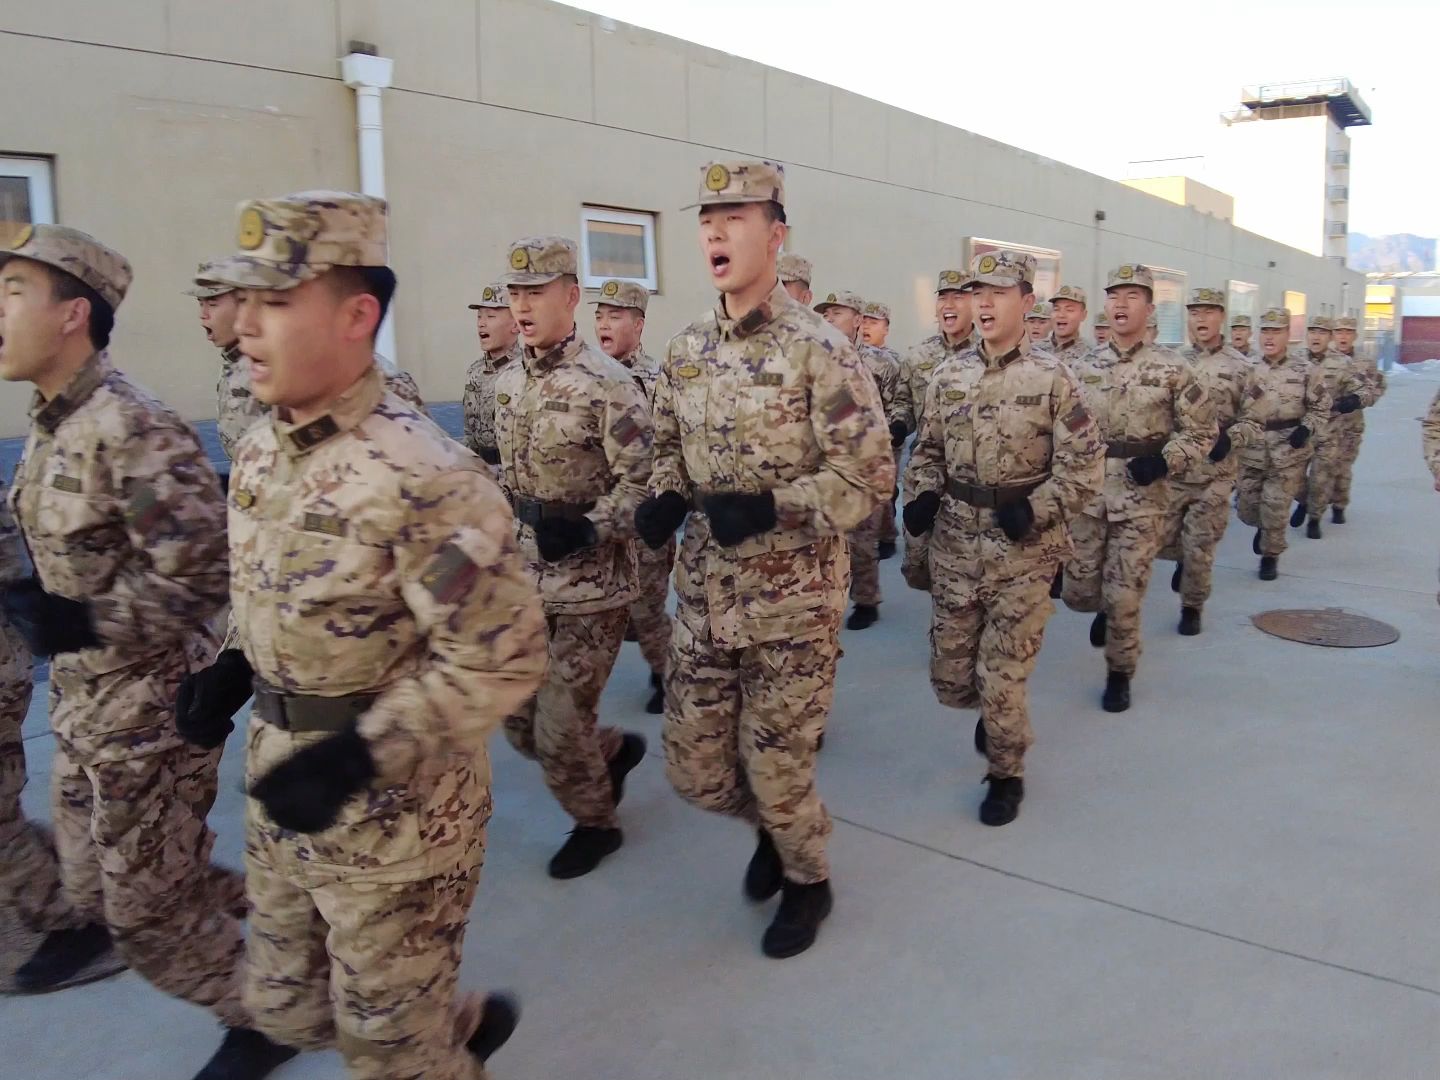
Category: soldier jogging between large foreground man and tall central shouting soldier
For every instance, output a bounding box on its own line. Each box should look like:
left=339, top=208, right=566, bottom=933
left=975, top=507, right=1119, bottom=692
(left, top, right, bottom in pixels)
left=495, top=236, right=651, bottom=878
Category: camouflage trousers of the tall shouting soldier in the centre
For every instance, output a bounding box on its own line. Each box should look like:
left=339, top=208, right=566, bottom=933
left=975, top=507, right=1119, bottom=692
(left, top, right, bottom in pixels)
left=664, top=612, right=840, bottom=884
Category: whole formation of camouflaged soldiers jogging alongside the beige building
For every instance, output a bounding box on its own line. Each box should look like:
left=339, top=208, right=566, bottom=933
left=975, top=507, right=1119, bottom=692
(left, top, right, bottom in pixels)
left=0, top=161, right=1416, bottom=1080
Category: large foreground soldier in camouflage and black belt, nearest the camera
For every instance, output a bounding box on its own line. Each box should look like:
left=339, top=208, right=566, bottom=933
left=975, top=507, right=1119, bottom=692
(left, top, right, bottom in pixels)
left=177, top=192, right=544, bottom=1080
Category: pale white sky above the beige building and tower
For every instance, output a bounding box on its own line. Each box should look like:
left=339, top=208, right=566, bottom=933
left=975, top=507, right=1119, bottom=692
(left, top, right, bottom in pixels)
left=570, top=0, right=1440, bottom=236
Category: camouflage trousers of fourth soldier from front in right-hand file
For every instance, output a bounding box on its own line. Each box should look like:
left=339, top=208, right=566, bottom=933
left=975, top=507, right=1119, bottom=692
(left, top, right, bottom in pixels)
left=1063, top=514, right=1165, bottom=675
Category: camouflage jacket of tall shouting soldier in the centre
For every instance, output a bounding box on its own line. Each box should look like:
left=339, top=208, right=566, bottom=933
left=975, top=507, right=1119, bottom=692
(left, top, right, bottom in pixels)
left=651, top=285, right=894, bottom=648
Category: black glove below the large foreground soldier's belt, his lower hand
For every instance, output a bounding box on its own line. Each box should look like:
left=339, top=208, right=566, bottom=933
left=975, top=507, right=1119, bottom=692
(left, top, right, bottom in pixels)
left=251, top=727, right=376, bottom=832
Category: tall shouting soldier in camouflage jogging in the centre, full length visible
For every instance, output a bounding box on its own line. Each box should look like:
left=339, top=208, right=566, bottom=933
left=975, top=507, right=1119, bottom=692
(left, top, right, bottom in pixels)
left=635, top=161, right=894, bottom=958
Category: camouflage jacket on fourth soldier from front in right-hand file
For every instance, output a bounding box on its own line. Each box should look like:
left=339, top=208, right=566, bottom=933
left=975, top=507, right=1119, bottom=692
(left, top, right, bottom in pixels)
left=1070, top=340, right=1220, bottom=520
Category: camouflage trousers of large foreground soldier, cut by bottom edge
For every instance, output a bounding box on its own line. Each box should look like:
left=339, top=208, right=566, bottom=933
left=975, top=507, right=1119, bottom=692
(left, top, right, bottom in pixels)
left=245, top=823, right=490, bottom=1080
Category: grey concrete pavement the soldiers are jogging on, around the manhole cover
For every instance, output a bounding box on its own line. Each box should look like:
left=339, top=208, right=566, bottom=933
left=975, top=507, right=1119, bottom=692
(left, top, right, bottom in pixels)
left=0, top=376, right=1440, bottom=1080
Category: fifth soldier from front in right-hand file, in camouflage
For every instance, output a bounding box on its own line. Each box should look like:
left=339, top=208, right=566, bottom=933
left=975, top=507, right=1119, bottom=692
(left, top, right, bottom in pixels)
left=1158, top=288, right=1250, bottom=636
